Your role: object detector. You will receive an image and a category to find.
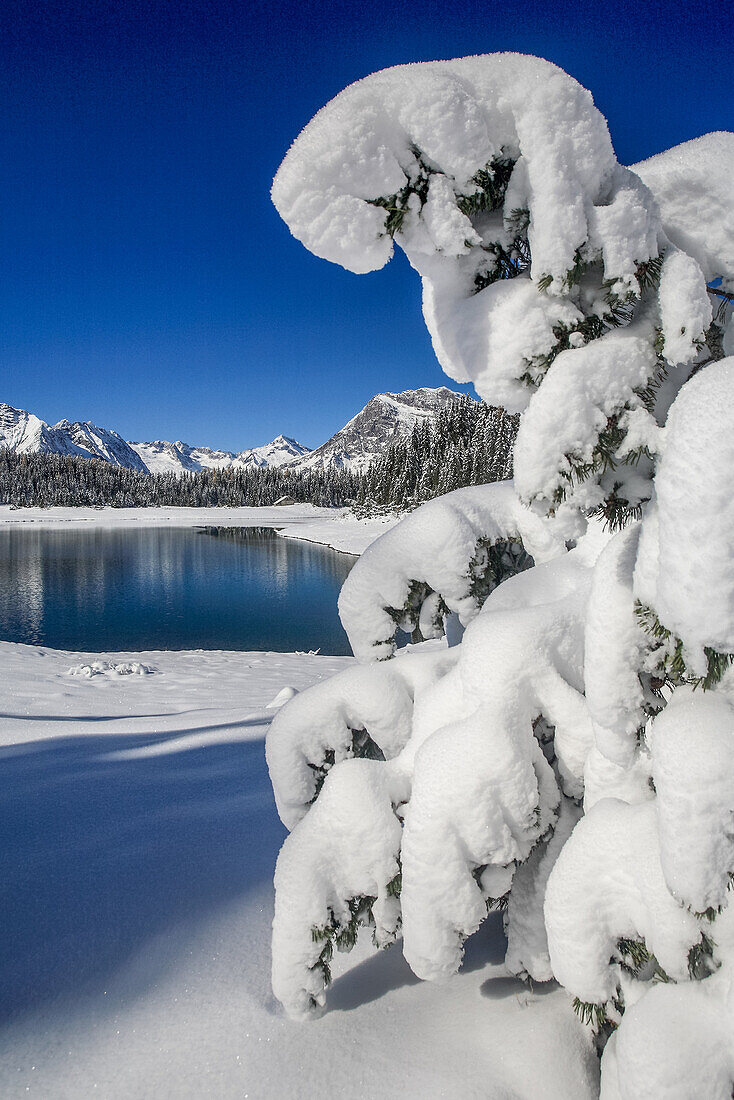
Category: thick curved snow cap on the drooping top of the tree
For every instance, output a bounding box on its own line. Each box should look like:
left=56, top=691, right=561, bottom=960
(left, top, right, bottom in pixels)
left=273, top=54, right=639, bottom=279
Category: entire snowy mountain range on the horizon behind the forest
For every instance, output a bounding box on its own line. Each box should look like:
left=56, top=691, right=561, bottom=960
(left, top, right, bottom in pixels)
left=0, top=386, right=464, bottom=474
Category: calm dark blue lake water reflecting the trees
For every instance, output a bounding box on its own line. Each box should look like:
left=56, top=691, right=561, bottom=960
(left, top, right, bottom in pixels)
left=0, top=527, right=355, bottom=655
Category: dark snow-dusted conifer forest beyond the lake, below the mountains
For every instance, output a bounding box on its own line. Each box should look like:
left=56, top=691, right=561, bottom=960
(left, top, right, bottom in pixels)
left=0, top=396, right=517, bottom=510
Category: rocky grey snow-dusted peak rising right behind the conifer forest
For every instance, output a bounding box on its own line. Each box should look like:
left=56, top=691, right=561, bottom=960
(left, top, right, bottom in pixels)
left=294, top=386, right=457, bottom=471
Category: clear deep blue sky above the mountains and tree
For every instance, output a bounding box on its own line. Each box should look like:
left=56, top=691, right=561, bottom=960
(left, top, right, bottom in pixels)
left=0, top=0, right=734, bottom=450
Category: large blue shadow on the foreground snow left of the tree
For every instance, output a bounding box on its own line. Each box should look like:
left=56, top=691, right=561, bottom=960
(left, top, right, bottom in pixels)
left=0, top=719, right=285, bottom=1021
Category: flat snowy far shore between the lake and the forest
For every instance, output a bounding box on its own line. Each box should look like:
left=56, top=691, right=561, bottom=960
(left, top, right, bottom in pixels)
left=0, top=504, right=397, bottom=554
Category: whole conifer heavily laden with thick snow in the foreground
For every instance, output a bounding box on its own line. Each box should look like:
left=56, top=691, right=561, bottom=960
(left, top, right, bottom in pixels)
left=267, top=54, right=734, bottom=1098
